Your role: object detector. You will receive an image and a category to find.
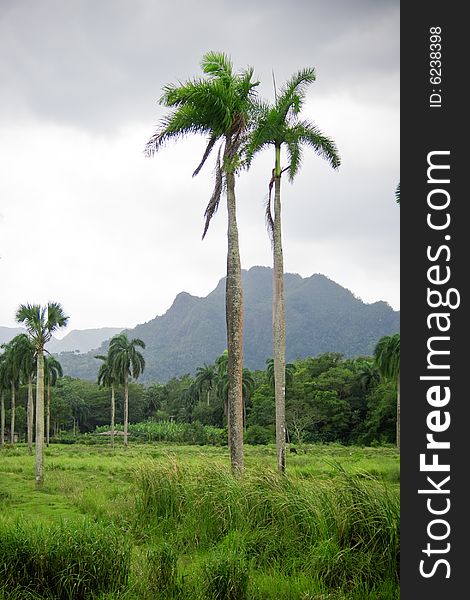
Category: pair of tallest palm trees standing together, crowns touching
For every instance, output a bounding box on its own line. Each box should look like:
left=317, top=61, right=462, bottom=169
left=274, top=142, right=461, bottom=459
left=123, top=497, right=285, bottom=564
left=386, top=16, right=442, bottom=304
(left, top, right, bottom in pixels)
left=146, top=52, right=340, bottom=473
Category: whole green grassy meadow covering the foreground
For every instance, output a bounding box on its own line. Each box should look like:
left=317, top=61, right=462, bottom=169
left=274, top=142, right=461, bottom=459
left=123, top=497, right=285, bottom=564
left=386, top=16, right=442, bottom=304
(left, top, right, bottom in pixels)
left=0, top=444, right=399, bottom=600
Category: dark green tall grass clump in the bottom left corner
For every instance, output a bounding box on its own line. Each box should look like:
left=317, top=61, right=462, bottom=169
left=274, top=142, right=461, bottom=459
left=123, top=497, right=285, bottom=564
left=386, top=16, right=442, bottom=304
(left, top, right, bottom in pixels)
left=0, top=520, right=130, bottom=600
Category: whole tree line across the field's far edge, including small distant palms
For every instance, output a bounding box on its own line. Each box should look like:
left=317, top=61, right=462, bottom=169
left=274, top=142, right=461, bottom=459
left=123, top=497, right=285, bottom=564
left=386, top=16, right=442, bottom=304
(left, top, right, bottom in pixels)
left=0, top=334, right=399, bottom=448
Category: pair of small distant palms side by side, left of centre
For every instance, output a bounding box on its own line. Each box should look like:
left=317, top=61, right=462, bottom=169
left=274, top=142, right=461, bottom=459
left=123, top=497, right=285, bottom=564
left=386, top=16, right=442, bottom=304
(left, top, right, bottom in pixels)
left=95, top=333, right=145, bottom=448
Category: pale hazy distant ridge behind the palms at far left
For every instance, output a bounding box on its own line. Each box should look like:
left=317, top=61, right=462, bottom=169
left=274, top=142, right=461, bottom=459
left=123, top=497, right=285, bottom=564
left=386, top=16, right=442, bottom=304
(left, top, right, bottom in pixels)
left=0, top=327, right=124, bottom=354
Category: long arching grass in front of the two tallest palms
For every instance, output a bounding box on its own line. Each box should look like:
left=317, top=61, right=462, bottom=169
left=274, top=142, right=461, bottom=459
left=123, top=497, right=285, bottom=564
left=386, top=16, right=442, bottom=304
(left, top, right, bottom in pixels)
left=135, top=461, right=399, bottom=589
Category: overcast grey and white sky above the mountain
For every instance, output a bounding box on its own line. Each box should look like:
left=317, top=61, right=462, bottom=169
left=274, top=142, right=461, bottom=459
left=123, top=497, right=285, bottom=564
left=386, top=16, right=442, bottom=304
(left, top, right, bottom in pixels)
left=0, top=0, right=400, bottom=337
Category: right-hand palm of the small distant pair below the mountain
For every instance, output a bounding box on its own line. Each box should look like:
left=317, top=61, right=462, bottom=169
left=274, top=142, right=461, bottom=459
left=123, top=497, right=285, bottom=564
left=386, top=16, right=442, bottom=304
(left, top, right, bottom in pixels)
left=108, top=333, right=145, bottom=448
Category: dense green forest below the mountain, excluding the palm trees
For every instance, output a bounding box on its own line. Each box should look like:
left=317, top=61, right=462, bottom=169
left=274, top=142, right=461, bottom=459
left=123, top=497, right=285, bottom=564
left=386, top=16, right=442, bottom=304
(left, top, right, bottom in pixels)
left=0, top=352, right=397, bottom=446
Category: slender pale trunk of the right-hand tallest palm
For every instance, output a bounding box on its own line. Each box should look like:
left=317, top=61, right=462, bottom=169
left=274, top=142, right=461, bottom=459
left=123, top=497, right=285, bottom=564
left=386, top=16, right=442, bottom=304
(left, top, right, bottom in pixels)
left=273, top=163, right=286, bottom=473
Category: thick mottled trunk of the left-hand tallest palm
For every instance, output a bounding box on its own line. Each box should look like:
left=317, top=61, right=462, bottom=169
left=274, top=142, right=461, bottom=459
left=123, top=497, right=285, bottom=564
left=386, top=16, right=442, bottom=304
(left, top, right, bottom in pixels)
left=225, top=173, right=244, bottom=474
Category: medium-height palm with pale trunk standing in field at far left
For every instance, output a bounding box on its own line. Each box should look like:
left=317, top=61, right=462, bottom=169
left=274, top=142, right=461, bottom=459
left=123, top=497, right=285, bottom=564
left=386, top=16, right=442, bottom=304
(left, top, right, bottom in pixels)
left=16, top=302, right=69, bottom=487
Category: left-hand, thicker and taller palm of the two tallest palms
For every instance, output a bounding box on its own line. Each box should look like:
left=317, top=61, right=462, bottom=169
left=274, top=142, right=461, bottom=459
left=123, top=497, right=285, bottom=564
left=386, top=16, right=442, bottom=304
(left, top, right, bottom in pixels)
left=146, top=52, right=258, bottom=473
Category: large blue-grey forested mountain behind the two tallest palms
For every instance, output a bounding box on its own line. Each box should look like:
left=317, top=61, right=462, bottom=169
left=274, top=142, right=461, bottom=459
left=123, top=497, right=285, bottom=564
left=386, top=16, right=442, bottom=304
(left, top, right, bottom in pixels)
left=59, top=267, right=400, bottom=382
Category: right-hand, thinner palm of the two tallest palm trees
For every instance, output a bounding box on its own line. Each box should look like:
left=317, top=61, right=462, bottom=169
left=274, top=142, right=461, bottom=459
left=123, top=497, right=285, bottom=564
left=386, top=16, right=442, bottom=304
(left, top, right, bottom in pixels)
left=246, top=68, right=340, bottom=473
